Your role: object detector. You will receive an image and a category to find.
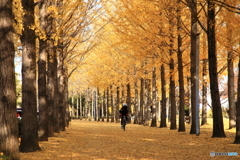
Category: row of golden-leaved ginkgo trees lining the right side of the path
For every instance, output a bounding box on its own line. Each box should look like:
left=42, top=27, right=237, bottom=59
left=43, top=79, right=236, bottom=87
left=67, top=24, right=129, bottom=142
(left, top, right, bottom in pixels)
left=70, top=0, right=240, bottom=143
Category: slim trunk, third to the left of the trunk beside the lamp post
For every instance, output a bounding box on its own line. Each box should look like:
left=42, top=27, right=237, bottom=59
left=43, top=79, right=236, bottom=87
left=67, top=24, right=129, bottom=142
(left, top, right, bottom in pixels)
left=160, top=64, right=167, bottom=128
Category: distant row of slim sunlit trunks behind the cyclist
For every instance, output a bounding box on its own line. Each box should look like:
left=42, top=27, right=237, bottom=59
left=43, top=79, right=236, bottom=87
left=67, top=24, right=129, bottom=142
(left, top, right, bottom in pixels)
left=69, top=82, right=174, bottom=125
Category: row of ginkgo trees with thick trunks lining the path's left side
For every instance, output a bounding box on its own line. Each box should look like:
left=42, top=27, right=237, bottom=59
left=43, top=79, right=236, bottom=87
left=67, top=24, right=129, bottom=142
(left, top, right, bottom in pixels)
left=0, top=0, right=101, bottom=160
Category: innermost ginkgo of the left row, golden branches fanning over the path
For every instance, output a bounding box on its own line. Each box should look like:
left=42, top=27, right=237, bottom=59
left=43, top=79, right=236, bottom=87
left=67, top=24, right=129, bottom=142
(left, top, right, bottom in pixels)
left=45, top=1, right=101, bottom=134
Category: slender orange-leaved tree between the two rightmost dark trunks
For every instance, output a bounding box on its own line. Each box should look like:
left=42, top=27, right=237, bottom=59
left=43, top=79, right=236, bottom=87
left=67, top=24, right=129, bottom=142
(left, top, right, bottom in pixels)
left=217, top=1, right=239, bottom=129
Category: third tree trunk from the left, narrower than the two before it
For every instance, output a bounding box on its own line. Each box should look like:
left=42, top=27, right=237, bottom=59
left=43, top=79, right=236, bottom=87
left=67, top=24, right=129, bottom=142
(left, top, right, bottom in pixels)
left=38, top=1, right=48, bottom=141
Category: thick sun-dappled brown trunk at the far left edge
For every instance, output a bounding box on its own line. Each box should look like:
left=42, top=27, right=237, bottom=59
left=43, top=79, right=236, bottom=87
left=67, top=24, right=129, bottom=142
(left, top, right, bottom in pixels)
left=0, top=0, right=20, bottom=160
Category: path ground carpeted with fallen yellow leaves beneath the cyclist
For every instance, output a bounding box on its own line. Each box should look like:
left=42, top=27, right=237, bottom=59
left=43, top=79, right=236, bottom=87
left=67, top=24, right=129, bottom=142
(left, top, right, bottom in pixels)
left=20, top=120, right=240, bottom=160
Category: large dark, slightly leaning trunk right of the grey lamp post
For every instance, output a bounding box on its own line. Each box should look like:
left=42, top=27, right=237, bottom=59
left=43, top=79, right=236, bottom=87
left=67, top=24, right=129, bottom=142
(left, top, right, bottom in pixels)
left=207, top=0, right=226, bottom=137
